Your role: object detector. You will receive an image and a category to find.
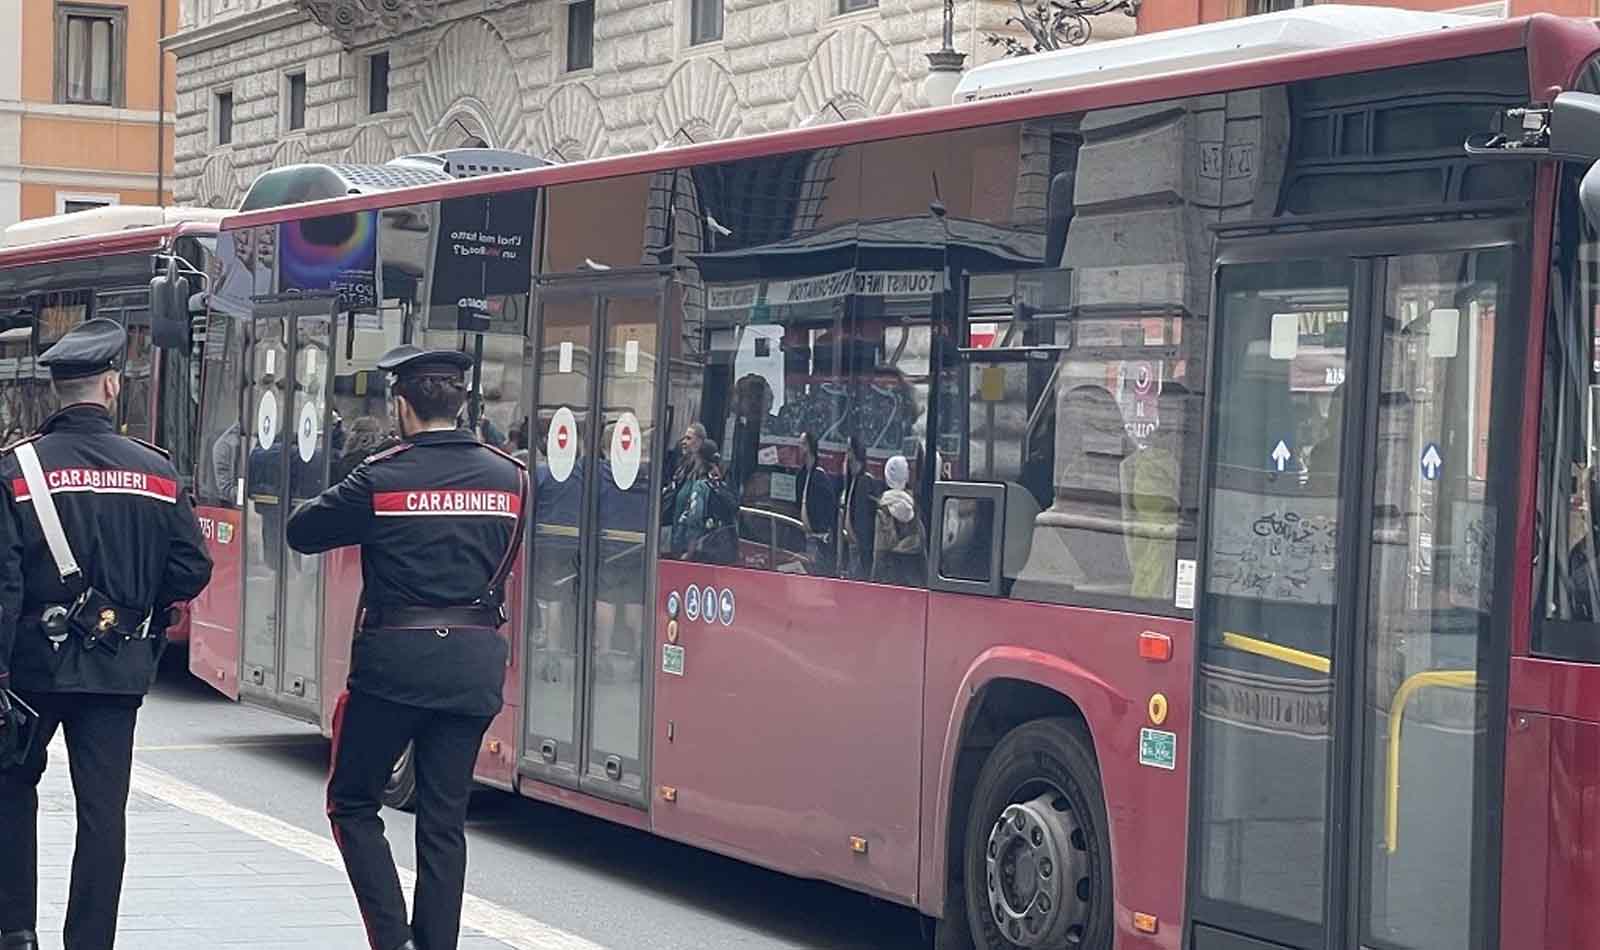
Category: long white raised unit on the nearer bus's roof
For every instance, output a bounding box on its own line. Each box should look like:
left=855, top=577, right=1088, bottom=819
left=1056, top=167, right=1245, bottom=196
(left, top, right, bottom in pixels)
left=955, top=3, right=1483, bottom=102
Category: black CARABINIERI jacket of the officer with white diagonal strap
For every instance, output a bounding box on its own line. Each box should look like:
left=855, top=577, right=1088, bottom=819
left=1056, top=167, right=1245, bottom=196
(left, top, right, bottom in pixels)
left=0, top=405, right=211, bottom=696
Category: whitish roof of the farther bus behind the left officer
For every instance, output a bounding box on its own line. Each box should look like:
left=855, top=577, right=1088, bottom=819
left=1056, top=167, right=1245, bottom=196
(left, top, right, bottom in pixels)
left=0, top=205, right=232, bottom=269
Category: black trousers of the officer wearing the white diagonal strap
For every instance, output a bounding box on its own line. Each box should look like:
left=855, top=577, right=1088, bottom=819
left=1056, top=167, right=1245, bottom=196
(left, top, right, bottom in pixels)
left=0, top=693, right=139, bottom=950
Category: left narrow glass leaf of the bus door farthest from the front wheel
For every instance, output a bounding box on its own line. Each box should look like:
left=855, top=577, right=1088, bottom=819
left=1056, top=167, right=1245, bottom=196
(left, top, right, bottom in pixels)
left=240, top=310, right=294, bottom=693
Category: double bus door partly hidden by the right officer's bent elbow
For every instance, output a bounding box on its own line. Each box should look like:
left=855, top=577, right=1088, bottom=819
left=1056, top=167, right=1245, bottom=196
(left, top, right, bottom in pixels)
left=240, top=296, right=338, bottom=721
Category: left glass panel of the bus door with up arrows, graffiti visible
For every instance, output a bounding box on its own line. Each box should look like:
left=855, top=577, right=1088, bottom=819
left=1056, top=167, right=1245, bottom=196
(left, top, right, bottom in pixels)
left=1195, top=252, right=1350, bottom=923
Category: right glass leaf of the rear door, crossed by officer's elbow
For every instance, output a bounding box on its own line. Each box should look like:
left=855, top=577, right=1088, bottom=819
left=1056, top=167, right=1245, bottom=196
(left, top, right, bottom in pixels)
left=283, top=304, right=333, bottom=705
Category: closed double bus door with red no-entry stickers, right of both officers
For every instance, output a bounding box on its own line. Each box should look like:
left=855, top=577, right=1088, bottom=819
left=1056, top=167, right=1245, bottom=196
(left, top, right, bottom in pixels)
left=520, top=270, right=674, bottom=806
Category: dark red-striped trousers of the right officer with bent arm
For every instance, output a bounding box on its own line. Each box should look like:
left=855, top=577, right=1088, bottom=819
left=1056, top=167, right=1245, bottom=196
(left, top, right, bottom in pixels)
left=328, top=693, right=491, bottom=950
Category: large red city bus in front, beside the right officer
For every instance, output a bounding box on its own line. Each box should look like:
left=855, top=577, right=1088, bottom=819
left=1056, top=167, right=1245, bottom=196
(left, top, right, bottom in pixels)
left=192, top=6, right=1600, bottom=950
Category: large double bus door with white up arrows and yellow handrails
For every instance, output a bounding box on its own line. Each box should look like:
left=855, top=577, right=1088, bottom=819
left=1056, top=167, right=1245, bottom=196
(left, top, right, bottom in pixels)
left=1190, top=221, right=1530, bottom=950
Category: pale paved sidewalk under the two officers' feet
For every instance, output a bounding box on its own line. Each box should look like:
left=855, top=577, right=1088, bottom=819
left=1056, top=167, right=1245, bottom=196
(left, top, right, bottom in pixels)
left=28, top=739, right=597, bottom=950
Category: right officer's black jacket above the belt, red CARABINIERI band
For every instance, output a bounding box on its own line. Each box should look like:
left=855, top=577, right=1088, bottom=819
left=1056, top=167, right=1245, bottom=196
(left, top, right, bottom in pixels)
left=288, top=429, right=522, bottom=609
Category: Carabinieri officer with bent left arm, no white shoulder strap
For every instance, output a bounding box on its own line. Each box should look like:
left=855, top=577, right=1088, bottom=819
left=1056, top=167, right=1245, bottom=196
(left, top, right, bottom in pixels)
left=288, top=344, right=526, bottom=950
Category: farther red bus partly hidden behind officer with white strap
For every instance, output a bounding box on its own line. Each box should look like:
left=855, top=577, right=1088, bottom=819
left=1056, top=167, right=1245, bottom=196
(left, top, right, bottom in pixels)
left=0, top=205, right=226, bottom=643
